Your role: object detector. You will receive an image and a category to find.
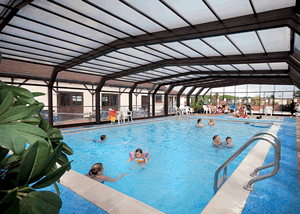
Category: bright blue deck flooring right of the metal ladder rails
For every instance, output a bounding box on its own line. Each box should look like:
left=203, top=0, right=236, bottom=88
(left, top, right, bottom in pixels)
left=243, top=118, right=300, bottom=214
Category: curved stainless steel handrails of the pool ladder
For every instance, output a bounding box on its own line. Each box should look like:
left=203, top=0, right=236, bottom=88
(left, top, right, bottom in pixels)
left=214, top=132, right=281, bottom=193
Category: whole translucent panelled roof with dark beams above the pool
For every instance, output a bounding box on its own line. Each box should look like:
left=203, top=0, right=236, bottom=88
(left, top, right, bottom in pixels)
left=0, top=0, right=300, bottom=89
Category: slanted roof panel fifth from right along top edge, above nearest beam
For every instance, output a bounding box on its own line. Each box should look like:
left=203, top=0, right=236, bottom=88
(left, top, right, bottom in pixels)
left=91, top=0, right=164, bottom=32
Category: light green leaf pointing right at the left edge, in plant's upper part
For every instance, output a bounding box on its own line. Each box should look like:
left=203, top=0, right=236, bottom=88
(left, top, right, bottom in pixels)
left=0, top=105, right=35, bottom=124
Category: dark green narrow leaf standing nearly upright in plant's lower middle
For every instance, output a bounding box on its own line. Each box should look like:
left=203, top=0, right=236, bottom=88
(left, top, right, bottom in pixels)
left=17, top=141, right=39, bottom=186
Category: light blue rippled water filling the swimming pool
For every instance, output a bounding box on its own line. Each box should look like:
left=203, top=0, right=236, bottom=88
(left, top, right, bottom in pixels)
left=63, top=118, right=268, bottom=213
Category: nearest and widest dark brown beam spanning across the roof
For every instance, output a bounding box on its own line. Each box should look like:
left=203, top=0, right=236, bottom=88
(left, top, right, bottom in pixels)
left=52, top=7, right=300, bottom=70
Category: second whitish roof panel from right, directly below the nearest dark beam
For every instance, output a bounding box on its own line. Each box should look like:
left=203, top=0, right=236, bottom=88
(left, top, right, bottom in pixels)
left=228, top=32, right=264, bottom=54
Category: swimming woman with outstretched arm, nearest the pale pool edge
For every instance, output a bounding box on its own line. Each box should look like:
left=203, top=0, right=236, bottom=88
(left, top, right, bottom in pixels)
left=85, top=163, right=129, bottom=183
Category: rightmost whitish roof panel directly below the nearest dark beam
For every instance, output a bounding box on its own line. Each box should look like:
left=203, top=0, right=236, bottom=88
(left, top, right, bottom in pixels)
left=257, top=27, right=291, bottom=52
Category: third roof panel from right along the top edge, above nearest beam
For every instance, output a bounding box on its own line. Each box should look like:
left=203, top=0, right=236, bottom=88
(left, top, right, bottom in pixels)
left=166, top=0, right=218, bottom=25
